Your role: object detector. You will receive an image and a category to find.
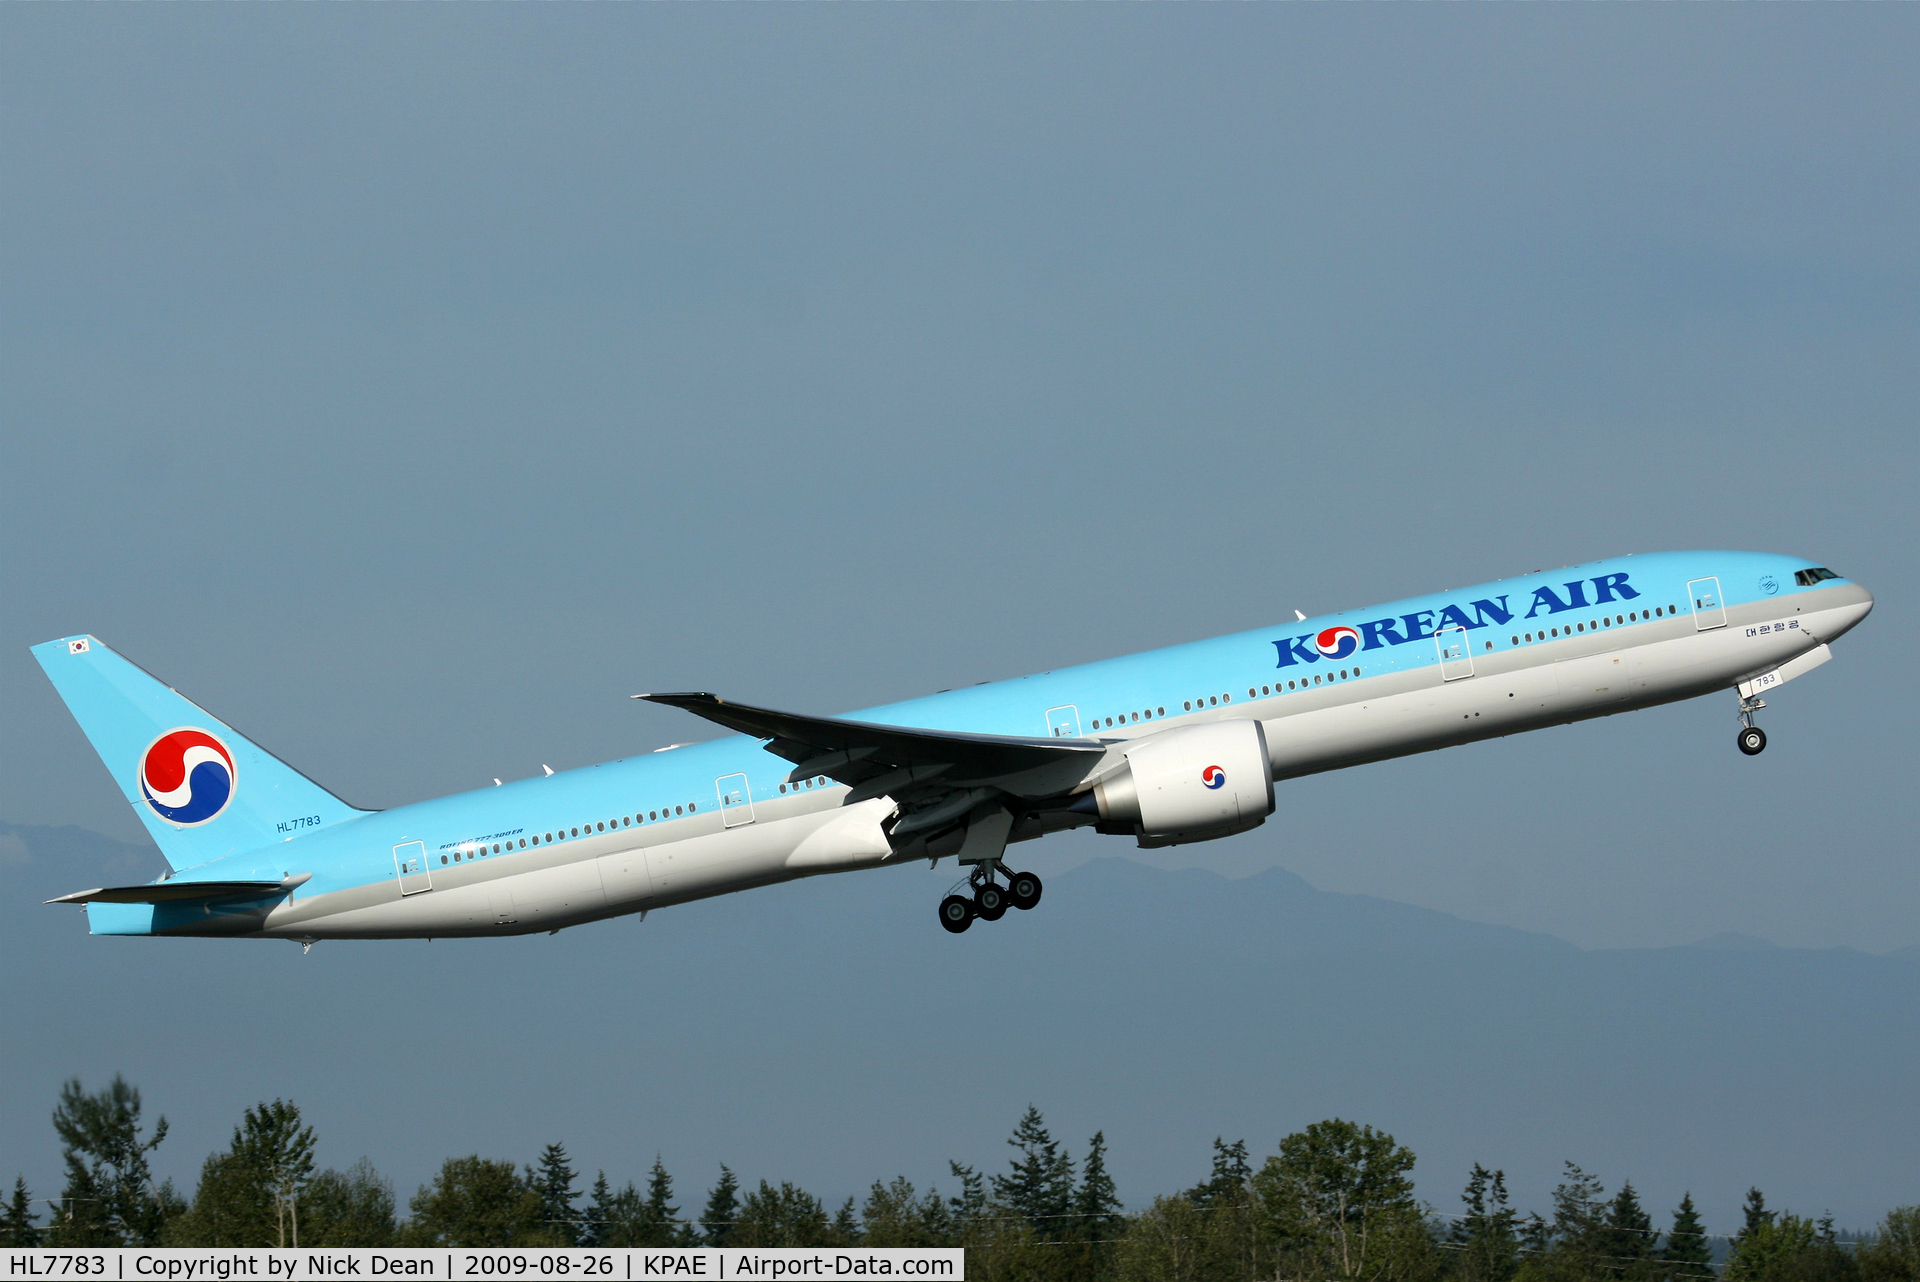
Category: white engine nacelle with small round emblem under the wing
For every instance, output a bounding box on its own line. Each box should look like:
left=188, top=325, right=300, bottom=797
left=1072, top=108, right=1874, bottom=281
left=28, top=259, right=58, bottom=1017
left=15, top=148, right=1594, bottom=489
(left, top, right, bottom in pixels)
left=1092, top=720, right=1273, bottom=846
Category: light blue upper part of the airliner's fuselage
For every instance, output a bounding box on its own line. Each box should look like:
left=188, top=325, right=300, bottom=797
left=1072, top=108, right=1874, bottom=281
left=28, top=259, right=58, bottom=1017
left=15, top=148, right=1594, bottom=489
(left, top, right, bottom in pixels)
left=161, top=551, right=1845, bottom=909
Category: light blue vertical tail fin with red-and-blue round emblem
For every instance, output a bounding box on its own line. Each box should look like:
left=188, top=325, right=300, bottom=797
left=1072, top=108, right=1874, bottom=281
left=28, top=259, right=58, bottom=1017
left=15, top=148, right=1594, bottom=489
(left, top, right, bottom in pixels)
left=33, top=637, right=367, bottom=867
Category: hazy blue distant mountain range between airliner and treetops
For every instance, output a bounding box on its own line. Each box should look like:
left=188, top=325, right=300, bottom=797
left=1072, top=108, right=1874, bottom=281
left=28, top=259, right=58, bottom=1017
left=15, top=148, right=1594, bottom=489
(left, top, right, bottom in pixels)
left=0, top=825, right=1920, bottom=1230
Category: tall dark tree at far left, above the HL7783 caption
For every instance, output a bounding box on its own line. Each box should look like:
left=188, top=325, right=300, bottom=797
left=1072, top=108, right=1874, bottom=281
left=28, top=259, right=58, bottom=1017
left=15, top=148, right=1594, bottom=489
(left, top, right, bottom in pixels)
left=46, top=1075, right=182, bottom=1246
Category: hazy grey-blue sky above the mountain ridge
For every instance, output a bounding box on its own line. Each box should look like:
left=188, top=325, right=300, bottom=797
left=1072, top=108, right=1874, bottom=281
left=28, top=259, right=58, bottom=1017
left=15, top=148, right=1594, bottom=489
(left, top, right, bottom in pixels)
left=0, top=6, right=1920, bottom=950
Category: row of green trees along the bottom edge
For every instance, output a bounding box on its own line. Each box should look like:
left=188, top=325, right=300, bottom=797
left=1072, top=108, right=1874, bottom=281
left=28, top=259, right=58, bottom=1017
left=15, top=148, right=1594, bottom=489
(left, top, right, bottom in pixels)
left=0, top=1077, right=1920, bottom=1282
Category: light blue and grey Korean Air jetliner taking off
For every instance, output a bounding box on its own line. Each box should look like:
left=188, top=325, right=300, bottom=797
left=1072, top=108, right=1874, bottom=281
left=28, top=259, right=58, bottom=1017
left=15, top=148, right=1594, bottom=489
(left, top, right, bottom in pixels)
left=33, top=553, right=1874, bottom=946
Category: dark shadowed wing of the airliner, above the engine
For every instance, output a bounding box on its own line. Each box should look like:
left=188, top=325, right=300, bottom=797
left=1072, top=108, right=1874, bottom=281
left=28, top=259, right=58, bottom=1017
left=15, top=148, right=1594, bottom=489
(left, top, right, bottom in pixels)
left=634, top=693, right=1106, bottom=795
